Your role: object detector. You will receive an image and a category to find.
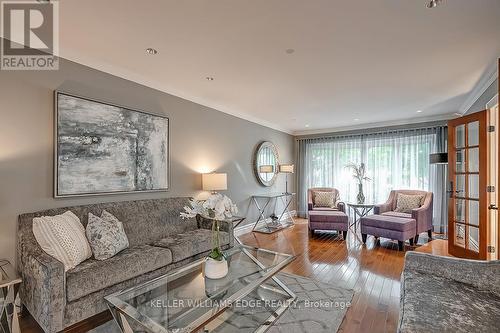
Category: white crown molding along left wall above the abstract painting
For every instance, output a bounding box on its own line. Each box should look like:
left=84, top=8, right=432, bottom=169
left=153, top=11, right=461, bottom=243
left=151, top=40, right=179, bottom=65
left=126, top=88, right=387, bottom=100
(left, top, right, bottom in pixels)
left=60, top=48, right=292, bottom=134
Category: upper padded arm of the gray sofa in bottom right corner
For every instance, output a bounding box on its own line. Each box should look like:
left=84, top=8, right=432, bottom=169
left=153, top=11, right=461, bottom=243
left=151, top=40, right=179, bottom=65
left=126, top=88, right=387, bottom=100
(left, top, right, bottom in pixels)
left=403, top=251, right=500, bottom=296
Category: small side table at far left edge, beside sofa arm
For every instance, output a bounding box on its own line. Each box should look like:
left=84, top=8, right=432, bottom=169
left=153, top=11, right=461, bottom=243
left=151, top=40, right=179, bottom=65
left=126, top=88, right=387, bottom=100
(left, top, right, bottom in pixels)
left=0, top=259, right=22, bottom=333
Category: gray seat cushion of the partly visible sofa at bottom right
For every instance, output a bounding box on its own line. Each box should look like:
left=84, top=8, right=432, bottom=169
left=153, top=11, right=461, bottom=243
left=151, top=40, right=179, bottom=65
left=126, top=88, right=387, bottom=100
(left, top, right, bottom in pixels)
left=399, top=271, right=500, bottom=333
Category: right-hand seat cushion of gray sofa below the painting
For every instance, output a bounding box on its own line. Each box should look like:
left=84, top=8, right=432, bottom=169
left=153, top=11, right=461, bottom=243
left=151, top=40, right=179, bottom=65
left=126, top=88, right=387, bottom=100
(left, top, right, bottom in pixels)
left=151, top=229, right=229, bottom=262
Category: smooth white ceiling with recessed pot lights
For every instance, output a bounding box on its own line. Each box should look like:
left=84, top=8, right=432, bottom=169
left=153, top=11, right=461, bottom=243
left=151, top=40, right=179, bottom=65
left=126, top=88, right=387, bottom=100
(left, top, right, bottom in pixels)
left=55, top=0, right=500, bottom=134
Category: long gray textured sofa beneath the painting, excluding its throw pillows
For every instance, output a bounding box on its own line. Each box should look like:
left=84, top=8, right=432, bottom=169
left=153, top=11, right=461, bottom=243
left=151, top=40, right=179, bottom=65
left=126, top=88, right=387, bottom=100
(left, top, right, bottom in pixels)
left=17, top=198, right=234, bottom=333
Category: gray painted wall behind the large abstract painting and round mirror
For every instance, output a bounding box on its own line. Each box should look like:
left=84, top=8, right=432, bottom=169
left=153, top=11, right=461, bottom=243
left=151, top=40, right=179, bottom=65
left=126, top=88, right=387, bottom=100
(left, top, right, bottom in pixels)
left=0, top=60, right=295, bottom=261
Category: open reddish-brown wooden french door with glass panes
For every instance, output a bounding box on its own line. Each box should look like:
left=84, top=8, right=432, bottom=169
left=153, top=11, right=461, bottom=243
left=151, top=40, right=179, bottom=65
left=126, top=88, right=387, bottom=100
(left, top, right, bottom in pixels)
left=448, top=111, right=488, bottom=259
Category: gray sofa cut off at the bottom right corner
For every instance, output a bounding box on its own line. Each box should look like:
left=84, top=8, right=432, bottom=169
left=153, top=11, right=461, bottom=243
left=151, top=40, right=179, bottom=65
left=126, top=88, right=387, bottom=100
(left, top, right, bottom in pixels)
left=398, top=252, right=500, bottom=333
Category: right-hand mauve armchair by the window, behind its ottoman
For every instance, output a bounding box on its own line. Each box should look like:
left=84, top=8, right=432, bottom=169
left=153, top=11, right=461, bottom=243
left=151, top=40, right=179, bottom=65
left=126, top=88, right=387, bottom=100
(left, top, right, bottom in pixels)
left=373, top=190, right=433, bottom=242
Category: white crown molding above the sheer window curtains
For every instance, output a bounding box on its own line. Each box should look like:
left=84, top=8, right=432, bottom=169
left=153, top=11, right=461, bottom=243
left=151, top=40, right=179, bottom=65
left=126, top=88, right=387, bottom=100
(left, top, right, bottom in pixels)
left=293, top=113, right=457, bottom=136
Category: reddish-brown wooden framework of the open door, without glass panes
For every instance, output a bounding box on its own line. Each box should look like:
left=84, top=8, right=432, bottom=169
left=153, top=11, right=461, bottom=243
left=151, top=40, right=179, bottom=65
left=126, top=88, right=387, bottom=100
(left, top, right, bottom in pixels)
left=448, top=110, right=489, bottom=259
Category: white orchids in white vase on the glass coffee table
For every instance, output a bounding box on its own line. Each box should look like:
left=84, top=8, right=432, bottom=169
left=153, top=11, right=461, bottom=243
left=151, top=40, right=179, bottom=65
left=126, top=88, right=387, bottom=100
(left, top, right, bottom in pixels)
left=181, top=193, right=238, bottom=279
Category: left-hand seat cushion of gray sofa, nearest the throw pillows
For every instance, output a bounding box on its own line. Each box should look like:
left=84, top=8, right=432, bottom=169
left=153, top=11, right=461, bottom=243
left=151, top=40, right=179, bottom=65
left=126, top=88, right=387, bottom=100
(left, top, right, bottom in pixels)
left=66, top=245, right=172, bottom=302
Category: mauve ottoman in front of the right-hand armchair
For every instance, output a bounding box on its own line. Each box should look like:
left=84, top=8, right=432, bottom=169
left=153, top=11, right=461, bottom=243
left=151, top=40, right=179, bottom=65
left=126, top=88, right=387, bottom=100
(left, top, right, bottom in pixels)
left=360, top=215, right=417, bottom=251
